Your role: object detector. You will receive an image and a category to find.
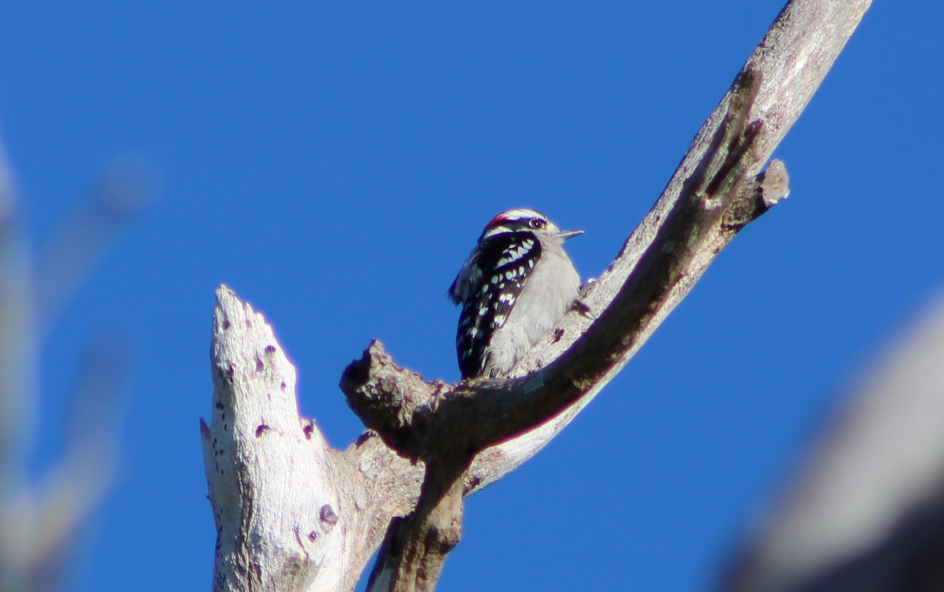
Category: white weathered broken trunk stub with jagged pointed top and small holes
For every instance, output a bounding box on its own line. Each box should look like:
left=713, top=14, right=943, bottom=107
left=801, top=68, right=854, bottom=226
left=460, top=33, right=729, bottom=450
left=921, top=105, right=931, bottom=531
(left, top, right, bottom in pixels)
left=200, top=286, right=347, bottom=592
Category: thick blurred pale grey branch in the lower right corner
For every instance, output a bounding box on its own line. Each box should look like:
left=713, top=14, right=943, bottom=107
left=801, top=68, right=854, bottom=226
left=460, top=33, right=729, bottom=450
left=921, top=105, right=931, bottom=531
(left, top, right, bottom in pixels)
left=724, top=297, right=944, bottom=592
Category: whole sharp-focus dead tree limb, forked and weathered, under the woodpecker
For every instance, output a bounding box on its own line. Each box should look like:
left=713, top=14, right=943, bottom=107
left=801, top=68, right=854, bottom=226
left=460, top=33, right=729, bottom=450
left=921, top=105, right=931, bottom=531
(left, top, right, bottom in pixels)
left=203, top=0, right=870, bottom=591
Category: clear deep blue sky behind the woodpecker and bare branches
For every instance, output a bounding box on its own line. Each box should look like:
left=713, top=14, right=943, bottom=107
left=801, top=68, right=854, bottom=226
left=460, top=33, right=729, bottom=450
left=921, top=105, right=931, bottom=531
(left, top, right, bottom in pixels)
left=0, top=0, right=944, bottom=592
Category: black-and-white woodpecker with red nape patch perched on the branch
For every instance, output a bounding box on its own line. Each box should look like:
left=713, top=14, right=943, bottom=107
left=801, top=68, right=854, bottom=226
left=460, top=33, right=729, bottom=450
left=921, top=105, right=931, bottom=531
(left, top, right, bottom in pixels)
left=449, top=208, right=582, bottom=378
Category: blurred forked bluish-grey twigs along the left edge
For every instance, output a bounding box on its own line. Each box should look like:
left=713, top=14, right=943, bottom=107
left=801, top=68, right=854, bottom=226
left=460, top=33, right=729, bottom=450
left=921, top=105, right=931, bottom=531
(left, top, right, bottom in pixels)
left=0, top=134, right=149, bottom=592
